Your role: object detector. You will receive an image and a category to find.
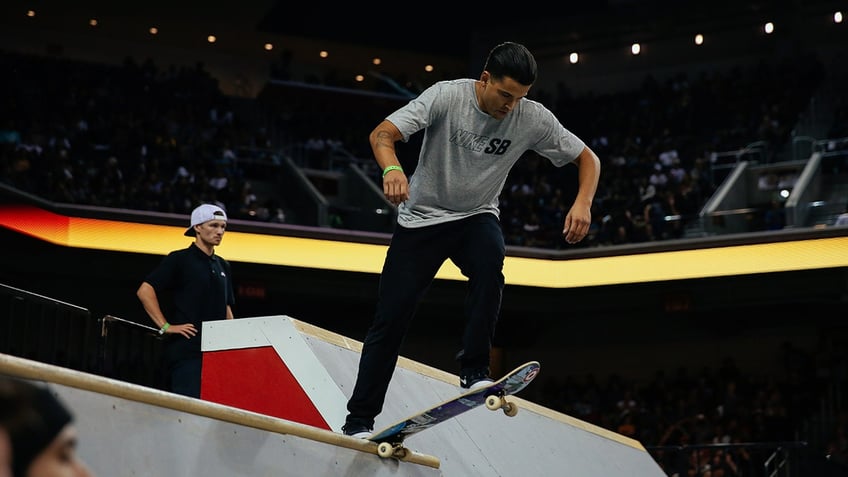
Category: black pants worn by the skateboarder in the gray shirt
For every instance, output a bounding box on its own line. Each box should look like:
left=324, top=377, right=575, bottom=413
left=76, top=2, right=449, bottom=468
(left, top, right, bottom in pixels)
left=347, top=213, right=505, bottom=427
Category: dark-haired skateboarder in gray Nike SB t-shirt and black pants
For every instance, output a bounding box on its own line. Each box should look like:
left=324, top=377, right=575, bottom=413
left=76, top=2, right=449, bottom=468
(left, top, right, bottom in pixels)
left=342, top=42, right=600, bottom=438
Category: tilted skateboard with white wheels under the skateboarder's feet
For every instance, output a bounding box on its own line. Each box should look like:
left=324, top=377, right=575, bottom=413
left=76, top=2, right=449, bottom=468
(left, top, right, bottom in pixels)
left=368, top=361, right=540, bottom=458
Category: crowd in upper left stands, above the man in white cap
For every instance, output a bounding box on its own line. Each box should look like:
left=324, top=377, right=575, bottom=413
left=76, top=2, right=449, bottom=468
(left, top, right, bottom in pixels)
left=0, top=53, right=283, bottom=220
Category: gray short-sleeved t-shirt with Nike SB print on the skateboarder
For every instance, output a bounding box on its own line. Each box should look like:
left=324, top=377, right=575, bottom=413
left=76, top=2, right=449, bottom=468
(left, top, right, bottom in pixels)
left=386, top=79, right=585, bottom=227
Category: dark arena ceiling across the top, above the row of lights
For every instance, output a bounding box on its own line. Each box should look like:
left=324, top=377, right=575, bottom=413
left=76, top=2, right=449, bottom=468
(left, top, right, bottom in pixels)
left=0, top=0, right=844, bottom=60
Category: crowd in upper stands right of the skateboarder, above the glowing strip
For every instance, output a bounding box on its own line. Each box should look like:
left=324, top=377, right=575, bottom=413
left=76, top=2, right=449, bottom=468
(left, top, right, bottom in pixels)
left=502, top=55, right=825, bottom=249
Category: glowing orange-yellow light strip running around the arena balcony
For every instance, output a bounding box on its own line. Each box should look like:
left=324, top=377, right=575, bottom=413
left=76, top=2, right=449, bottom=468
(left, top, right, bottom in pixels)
left=0, top=205, right=848, bottom=288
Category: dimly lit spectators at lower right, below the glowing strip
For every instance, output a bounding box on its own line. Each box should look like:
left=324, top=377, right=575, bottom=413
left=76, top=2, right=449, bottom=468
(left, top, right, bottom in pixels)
left=540, top=342, right=848, bottom=477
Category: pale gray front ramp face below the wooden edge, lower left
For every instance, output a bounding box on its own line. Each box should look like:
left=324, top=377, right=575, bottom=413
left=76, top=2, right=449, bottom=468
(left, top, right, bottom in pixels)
left=51, top=384, right=441, bottom=477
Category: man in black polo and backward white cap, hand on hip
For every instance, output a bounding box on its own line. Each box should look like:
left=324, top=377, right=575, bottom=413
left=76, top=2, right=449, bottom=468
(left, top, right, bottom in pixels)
left=136, top=204, right=235, bottom=398
